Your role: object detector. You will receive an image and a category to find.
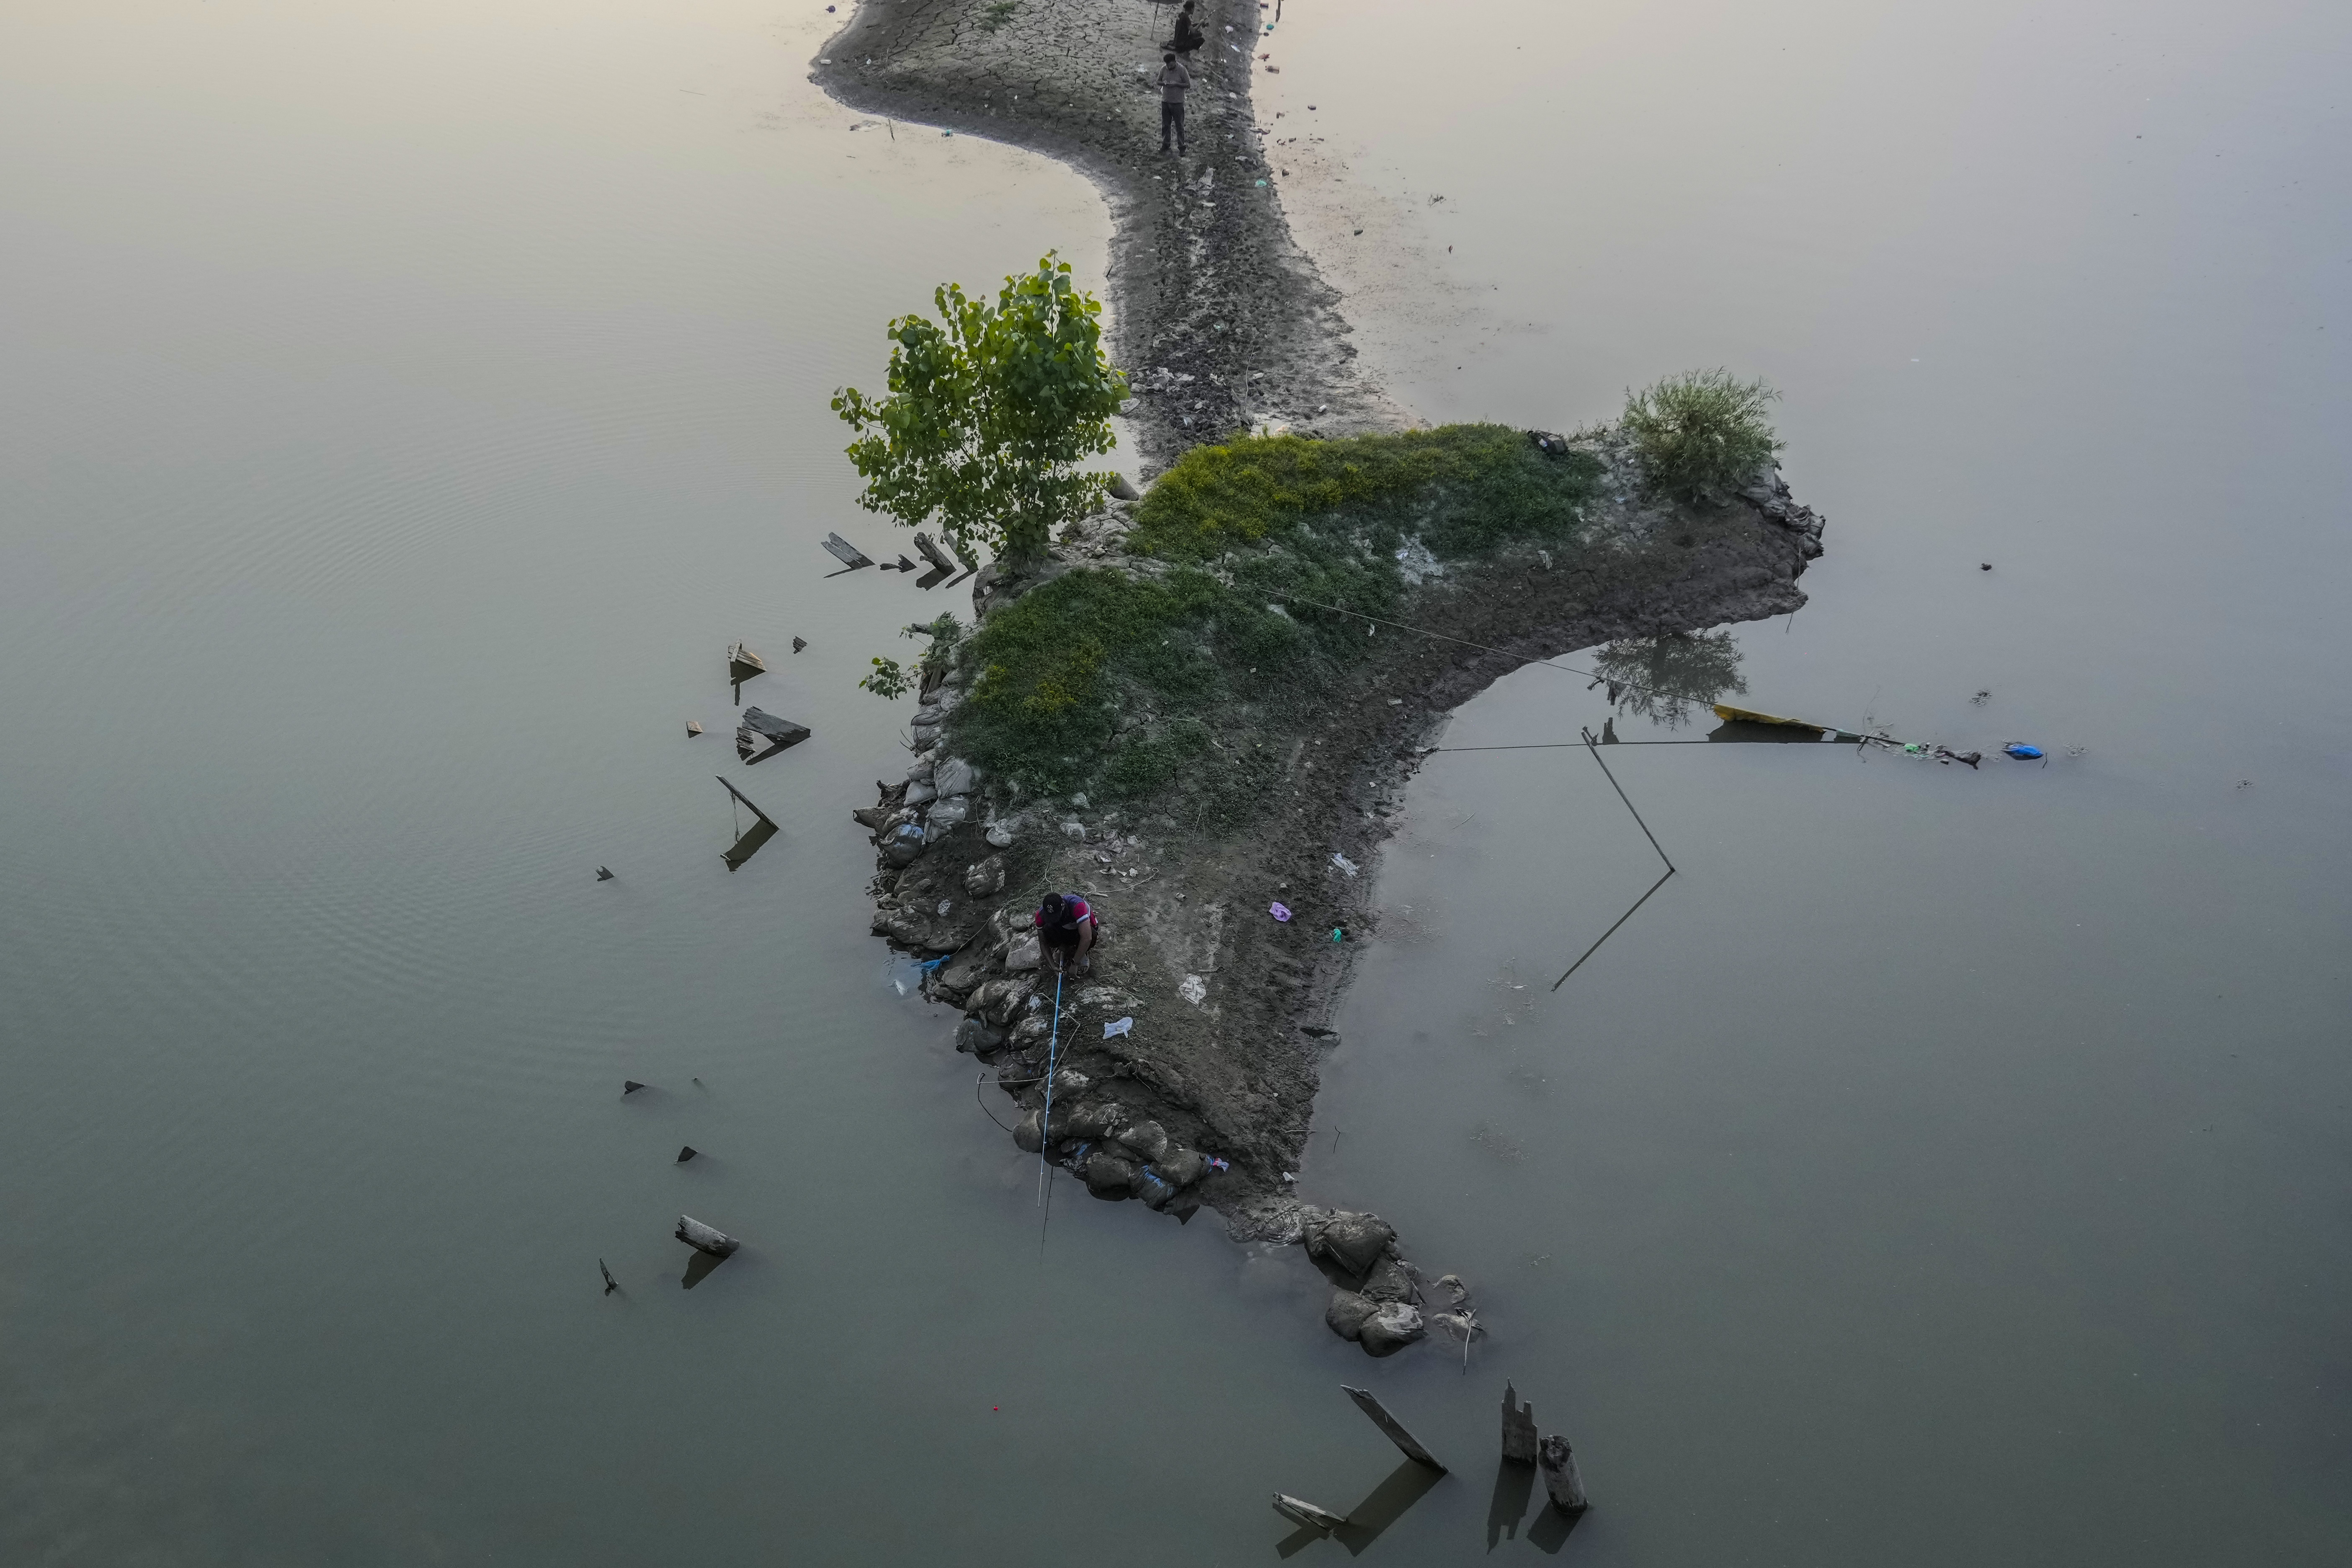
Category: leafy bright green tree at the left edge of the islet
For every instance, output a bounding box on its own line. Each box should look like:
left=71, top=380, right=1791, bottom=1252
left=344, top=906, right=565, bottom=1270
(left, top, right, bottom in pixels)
left=833, top=252, right=1127, bottom=564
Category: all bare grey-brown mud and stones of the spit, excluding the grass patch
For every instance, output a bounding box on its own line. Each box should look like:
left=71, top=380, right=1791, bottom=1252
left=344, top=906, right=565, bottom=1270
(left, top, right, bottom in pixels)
left=816, top=0, right=1823, bottom=1354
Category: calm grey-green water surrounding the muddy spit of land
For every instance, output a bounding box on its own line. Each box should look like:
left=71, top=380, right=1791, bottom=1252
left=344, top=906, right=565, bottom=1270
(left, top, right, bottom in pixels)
left=0, top=0, right=2352, bottom=1565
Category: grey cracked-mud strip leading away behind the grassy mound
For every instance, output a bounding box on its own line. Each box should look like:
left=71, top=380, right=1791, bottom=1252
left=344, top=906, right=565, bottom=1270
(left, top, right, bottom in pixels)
left=812, top=0, right=1409, bottom=472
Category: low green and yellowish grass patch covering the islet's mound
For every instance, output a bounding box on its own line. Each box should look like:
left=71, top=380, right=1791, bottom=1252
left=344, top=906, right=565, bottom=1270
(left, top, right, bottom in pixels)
left=950, top=426, right=1599, bottom=808
